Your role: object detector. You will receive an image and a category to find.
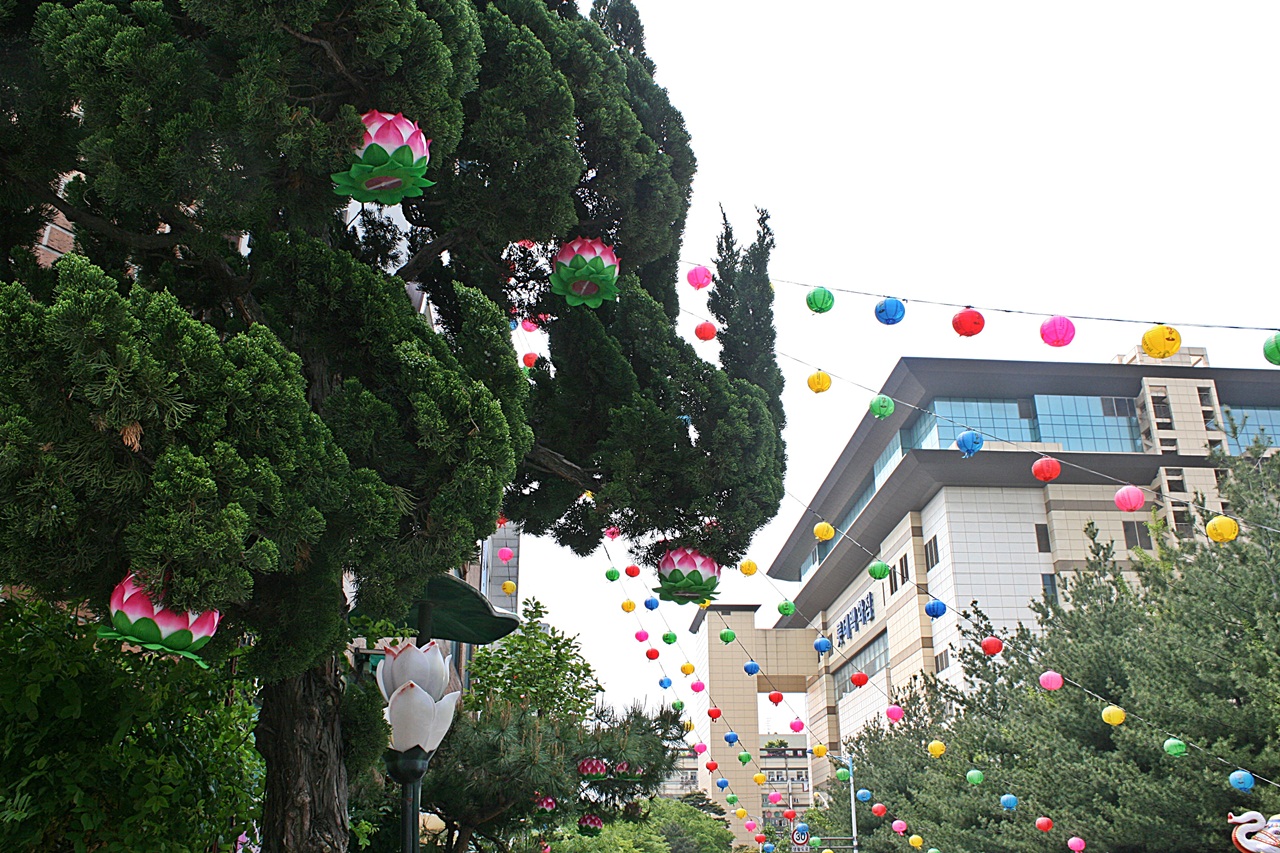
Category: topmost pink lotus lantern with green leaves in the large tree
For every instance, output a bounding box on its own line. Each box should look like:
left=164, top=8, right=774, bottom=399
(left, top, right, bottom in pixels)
left=329, top=110, right=435, bottom=205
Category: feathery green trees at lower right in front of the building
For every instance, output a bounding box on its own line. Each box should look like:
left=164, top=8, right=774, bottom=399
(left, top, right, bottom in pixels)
left=810, top=448, right=1280, bottom=853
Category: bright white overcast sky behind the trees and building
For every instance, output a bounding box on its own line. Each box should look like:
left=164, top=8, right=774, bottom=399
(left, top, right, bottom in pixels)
left=517, top=0, right=1280, bottom=727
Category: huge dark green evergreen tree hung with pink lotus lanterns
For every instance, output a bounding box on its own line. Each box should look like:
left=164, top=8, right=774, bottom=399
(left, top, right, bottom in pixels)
left=0, top=0, right=785, bottom=852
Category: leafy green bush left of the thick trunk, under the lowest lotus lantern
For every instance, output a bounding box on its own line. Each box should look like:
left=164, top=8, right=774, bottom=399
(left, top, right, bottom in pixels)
left=0, top=599, right=262, bottom=853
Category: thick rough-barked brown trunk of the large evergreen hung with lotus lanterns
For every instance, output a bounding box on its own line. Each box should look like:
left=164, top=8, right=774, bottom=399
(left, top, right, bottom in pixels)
left=255, top=658, right=348, bottom=853
